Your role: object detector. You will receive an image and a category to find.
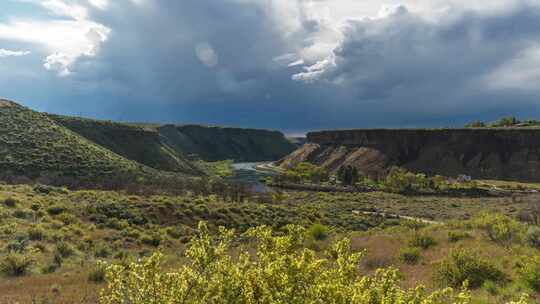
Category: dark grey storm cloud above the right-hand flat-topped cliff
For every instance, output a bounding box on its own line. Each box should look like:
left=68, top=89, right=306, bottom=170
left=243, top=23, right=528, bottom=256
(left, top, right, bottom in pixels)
left=297, top=6, right=540, bottom=124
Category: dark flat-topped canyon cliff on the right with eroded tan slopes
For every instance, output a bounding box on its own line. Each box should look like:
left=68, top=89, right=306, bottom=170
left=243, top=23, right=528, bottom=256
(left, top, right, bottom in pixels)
left=280, top=129, right=540, bottom=181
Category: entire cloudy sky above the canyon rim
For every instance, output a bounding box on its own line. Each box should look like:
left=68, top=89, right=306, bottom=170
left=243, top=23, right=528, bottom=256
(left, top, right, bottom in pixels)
left=0, top=0, right=540, bottom=134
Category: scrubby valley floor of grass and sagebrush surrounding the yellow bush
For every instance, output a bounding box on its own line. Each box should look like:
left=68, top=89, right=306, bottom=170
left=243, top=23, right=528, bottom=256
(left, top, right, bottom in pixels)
left=0, top=185, right=540, bottom=303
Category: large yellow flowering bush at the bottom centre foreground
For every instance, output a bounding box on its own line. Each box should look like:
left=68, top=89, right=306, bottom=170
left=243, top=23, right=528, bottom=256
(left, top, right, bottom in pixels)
left=100, top=223, right=525, bottom=304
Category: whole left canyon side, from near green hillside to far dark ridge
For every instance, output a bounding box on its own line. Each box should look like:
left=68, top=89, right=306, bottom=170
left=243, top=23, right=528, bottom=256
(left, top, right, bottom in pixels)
left=0, top=99, right=294, bottom=188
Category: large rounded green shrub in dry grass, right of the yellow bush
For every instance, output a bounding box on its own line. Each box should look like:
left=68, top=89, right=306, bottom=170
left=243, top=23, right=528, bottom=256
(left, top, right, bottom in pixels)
left=436, top=249, right=505, bottom=288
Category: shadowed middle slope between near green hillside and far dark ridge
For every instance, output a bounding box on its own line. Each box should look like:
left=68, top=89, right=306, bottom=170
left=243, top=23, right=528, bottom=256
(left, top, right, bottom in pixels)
left=50, top=115, right=201, bottom=174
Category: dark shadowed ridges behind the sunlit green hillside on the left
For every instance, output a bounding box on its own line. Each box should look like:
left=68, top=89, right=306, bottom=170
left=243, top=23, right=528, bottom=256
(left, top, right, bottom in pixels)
left=49, top=114, right=296, bottom=166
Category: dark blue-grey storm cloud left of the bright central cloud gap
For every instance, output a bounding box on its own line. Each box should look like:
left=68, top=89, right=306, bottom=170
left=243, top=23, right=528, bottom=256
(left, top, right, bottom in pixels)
left=54, top=0, right=332, bottom=127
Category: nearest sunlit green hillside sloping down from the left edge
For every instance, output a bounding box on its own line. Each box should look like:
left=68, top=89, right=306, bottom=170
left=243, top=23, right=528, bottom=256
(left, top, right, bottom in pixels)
left=0, top=100, right=149, bottom=183
